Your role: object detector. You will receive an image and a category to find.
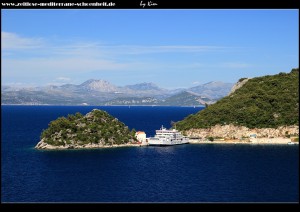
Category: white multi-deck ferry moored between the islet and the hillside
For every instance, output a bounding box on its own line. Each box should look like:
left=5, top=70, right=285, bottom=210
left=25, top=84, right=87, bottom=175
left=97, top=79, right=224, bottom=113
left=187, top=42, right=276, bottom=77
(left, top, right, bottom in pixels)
left=147, top=126, right=189, bottom=146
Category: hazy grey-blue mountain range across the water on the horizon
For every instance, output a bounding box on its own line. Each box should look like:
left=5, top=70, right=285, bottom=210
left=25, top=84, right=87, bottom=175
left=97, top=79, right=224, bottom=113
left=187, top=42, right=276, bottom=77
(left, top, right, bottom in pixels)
left=1, top=79, right=234, bottom=106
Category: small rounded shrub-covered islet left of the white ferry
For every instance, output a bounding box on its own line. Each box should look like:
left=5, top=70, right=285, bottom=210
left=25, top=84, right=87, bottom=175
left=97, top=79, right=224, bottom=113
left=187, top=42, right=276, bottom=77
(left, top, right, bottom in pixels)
left=35, top=109, right=137, bottom=149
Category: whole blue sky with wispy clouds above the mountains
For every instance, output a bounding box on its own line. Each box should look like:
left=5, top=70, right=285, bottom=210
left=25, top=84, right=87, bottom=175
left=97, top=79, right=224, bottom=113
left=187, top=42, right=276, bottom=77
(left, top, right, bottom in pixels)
left=1, top=9, right=299, bottom=89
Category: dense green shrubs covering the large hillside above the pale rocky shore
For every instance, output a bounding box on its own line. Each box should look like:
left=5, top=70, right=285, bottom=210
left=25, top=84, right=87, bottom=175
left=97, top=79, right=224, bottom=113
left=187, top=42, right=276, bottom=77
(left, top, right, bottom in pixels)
left=176, top=69, right=299, bottom=130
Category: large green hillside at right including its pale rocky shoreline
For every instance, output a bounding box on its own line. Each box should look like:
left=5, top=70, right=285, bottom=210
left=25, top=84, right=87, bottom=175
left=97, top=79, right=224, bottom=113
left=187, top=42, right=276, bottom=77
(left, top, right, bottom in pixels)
left=176, top=68, right=299, bottom=143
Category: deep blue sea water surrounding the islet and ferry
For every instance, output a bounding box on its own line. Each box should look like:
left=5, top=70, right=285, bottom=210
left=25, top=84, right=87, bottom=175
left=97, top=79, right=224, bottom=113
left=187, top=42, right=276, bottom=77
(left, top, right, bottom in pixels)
left=1, top=106, right=299, bottom=202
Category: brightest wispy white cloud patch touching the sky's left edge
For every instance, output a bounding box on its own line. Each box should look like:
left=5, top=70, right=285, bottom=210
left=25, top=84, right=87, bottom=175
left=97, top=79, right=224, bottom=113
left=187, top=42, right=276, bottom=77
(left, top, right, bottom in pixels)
left=1, top=32, right=43, bottom=50
